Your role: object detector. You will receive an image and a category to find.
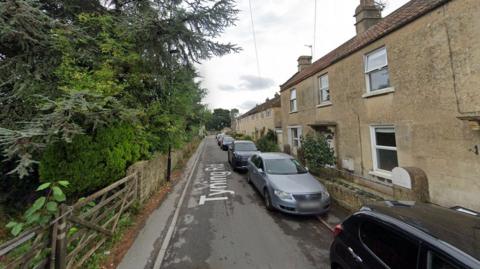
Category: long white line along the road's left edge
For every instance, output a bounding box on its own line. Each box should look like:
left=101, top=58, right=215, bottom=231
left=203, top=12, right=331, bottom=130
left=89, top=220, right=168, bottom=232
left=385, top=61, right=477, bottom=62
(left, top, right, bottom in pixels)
left=153, top=139, right=206, bottom=269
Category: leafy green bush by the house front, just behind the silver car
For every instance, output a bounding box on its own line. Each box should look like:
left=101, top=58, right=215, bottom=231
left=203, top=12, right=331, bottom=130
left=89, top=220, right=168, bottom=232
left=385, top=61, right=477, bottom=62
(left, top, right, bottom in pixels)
left=301, top=134, right=335, bottom=169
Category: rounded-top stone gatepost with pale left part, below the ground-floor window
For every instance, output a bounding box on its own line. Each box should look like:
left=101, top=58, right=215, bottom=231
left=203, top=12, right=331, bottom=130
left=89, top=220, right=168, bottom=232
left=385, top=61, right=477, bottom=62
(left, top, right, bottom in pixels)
left=392, top=167, right=430, bottom=202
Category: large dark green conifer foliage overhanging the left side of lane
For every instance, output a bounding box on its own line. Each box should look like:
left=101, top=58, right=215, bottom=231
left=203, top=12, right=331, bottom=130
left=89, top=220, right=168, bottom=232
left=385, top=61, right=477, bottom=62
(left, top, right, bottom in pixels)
left=0, top=0, right=239, bottom=177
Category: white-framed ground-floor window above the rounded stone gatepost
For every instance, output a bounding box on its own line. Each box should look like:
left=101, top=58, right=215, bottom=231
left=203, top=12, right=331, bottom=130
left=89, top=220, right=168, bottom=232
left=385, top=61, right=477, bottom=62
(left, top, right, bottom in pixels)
left=371, top=126, right=398, bottom=173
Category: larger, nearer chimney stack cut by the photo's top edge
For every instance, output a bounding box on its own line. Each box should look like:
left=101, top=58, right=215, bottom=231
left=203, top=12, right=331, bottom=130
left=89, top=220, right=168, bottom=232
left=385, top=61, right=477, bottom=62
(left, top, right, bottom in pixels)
left=354, top=0, right=382, bottom=35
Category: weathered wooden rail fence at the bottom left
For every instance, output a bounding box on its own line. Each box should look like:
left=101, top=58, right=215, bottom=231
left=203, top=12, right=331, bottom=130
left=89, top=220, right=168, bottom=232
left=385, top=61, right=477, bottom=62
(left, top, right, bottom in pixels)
left=0, top=173, right=138, bottom=269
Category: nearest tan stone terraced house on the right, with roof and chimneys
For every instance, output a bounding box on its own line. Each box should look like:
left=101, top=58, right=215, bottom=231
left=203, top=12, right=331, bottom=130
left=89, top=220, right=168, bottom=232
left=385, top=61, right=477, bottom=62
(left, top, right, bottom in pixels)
left=281, top=0, right=480, bottom=211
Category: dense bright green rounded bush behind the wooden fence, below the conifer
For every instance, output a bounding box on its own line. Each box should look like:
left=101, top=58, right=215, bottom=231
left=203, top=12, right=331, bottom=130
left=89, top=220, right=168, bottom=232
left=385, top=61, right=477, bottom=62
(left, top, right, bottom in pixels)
left=39, top=124, right=149, bottom=195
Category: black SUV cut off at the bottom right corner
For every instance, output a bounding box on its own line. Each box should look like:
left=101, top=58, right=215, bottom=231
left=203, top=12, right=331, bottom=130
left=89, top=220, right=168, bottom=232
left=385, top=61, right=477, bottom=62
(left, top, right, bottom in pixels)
left=330, top=201, right=480, bottom=269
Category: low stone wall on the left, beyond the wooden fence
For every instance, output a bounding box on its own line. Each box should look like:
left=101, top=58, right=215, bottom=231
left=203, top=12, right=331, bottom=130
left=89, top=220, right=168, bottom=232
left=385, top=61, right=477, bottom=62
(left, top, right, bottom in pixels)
left=127, top=140, right=199, bottom=203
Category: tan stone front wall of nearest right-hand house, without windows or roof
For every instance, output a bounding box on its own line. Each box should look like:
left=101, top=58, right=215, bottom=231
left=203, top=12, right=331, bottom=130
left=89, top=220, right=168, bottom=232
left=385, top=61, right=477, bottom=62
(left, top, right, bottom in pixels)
left=281, top=0, right=480, bottom=210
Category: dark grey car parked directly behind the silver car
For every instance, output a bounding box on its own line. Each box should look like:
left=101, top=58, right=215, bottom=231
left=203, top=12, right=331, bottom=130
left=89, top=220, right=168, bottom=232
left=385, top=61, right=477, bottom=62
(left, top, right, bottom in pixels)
left=228, top=140, right=260, bottom=170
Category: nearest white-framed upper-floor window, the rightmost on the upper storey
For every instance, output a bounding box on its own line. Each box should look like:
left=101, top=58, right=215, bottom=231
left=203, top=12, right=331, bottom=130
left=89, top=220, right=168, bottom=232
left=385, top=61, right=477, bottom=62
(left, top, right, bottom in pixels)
left=364, top=47, right=390, bottom=92
